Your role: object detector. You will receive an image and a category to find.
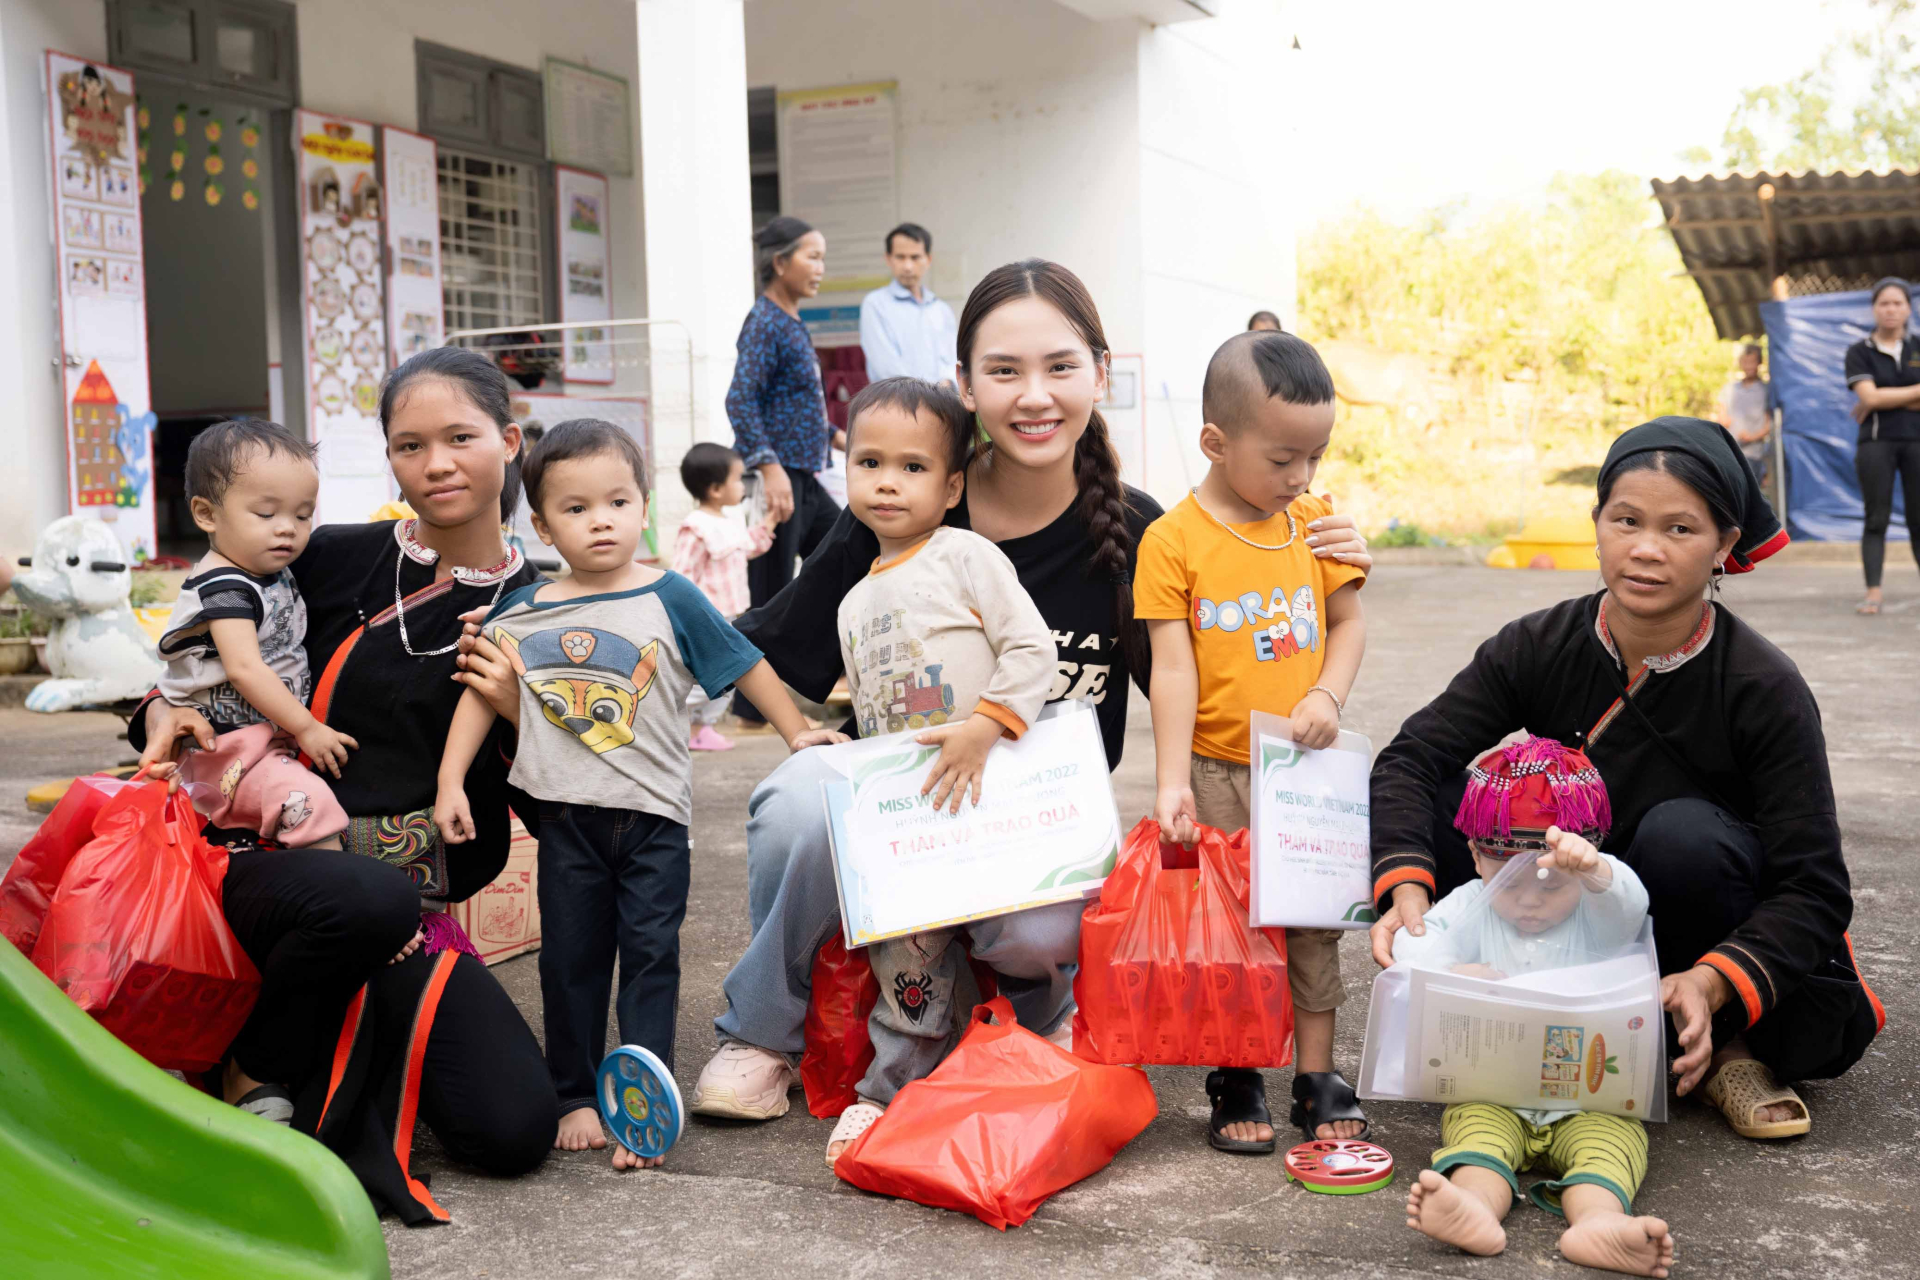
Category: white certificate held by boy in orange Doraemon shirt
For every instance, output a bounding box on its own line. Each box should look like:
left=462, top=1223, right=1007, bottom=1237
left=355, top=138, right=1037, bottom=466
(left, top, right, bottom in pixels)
left=1248, top=712, right=1375, bottom=929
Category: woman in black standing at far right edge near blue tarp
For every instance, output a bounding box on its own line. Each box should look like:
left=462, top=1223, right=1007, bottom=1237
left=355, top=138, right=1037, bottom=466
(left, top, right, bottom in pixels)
left=1847, top=276, right=1920, bottom=614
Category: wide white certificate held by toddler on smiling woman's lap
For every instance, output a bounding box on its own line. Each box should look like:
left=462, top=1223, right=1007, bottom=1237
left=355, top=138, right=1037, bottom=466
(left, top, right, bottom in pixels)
left=814, top=702, right=1119, bottom=948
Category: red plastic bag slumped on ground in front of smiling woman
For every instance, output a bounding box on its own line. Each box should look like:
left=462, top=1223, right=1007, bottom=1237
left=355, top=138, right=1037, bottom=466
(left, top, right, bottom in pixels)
left=833, top=996, right=1160, bottom=1230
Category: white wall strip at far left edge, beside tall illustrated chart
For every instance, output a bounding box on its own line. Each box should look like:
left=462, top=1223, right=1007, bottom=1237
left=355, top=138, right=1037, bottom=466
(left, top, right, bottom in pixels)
left=0, top=0, right=108, bottom=560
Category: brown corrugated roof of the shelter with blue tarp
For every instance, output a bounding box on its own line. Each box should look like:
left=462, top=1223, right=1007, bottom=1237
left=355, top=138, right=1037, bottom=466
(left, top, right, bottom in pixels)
left=1653, top=171, right=1920, bottom=338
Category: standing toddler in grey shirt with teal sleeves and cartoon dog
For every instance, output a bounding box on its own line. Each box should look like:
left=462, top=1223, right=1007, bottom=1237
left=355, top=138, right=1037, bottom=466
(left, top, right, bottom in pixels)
left=434, top=418, right=847, bottom=1169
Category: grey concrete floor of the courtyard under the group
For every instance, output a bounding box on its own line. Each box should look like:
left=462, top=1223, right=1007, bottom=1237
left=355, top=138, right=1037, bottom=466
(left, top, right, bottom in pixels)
left=0, top=566, right=1920, bottom=1280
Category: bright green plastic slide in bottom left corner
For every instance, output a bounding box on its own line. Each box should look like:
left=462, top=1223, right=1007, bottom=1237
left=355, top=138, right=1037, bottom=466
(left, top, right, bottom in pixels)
left=0, top=940, right=390, bottom=1280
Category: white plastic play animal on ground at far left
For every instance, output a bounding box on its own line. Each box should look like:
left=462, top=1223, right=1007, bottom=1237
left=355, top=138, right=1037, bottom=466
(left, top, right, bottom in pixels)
left=13, top=516, right=161, bottom=712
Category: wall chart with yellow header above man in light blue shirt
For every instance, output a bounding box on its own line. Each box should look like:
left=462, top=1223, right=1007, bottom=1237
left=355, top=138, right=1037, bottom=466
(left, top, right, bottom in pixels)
left=780, top=81, right=900, bottom=294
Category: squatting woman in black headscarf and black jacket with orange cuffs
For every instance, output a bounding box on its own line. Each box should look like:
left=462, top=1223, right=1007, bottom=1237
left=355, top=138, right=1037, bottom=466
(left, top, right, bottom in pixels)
left=1373, top=418, right=1885, bottom=1138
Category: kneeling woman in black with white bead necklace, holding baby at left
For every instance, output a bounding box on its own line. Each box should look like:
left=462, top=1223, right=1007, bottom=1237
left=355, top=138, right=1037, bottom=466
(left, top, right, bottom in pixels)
left=129, top=347, right=559, bottom=1226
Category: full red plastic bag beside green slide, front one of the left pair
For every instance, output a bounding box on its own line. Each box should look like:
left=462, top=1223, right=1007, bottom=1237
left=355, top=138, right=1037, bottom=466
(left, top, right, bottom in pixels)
left=33, top=783, right=259, bottom=1073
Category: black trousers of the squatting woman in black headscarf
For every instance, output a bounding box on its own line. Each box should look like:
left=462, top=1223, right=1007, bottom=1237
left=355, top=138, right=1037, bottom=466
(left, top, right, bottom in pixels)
left=1434, top=775, right=1878, bottom=1082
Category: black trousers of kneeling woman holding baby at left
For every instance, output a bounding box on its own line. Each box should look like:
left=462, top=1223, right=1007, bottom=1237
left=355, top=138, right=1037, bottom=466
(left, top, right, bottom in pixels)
left=225, top=848, right=557, bottom=1176
